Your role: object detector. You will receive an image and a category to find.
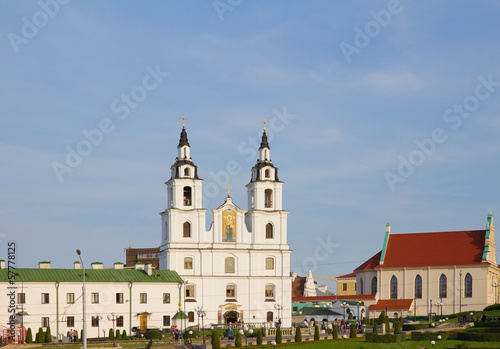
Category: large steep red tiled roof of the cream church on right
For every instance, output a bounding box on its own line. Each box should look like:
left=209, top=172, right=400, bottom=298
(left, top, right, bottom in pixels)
left=355, top=230, right=486, bottom=271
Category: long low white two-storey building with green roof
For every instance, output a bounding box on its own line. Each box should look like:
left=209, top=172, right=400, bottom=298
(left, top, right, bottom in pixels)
left=0, top=261, right=182, bottom=339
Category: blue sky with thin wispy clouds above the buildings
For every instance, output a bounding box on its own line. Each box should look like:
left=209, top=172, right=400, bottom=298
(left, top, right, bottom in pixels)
left=0, top=0, right=500, bottom=287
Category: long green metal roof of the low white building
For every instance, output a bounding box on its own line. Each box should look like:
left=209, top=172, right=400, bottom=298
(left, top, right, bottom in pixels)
left=0, top=268, right=182, bottom=283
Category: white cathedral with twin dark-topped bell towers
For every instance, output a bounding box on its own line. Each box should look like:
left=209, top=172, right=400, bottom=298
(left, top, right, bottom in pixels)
left=159, top=125, right=292, bottom=327
